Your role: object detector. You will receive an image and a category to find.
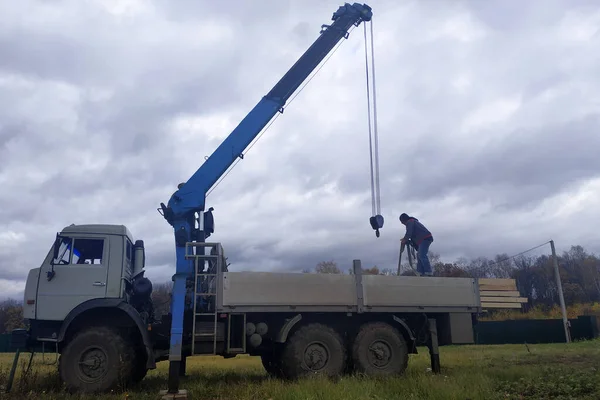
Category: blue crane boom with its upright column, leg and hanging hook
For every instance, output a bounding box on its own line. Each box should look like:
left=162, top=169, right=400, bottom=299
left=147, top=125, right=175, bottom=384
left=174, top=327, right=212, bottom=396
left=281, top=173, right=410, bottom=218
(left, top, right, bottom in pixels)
left=161, top=3, right=376, bottom=393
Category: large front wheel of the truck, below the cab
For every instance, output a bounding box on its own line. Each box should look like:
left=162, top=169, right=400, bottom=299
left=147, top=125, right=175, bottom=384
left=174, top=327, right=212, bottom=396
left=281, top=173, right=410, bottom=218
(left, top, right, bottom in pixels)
left=59, top=326, right=134, bottom=393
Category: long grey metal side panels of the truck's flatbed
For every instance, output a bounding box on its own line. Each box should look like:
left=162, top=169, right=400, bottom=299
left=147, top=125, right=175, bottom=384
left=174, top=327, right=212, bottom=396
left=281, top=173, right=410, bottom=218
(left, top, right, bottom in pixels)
left=217, top=268, right=480, bottom=312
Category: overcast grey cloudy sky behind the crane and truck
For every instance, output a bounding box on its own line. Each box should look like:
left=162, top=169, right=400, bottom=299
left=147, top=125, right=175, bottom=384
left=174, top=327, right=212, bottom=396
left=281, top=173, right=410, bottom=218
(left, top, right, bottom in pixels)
left=0, top=0, right=600, bottom=297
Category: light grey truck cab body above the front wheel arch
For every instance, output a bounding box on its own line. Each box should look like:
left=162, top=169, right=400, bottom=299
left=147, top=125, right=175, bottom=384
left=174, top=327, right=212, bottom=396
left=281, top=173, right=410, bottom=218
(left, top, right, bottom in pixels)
left=24, top=225, right=149, bottom=324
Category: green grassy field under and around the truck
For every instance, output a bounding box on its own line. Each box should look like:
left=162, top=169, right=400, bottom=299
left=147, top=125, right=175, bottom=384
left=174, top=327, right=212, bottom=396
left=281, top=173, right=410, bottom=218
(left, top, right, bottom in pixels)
left=0, top=340, right=600, bottom=400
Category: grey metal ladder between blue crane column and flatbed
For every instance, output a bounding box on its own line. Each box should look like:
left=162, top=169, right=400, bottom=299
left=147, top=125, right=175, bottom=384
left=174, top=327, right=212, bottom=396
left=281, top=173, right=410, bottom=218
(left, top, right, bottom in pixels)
left=185, top=242, right=224, bottom=355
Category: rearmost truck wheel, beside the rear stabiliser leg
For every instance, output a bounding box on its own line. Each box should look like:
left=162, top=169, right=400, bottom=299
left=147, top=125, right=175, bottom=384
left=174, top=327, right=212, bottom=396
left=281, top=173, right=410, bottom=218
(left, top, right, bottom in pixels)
left=352, top=322, right=408, bottom=376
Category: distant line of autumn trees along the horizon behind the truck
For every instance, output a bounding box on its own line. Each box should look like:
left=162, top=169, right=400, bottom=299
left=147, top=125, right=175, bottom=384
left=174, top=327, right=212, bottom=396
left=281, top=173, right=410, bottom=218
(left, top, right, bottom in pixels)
left=0, top=245, right=600, bottom=333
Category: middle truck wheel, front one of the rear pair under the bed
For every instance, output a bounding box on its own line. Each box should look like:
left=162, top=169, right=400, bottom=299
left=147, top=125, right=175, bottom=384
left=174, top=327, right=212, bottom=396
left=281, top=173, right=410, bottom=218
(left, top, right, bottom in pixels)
left=281, top=323, right=346, bottom=379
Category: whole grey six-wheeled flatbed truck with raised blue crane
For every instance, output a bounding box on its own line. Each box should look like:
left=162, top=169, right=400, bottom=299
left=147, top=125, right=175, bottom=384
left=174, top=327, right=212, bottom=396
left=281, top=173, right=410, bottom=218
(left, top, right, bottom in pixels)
left=12, top=3, right=481, bottom=396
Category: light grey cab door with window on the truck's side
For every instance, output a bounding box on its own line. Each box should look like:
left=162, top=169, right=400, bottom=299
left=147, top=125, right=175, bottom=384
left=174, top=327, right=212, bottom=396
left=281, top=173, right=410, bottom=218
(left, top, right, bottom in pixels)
left=36, top=235, right=109, bottom=321
